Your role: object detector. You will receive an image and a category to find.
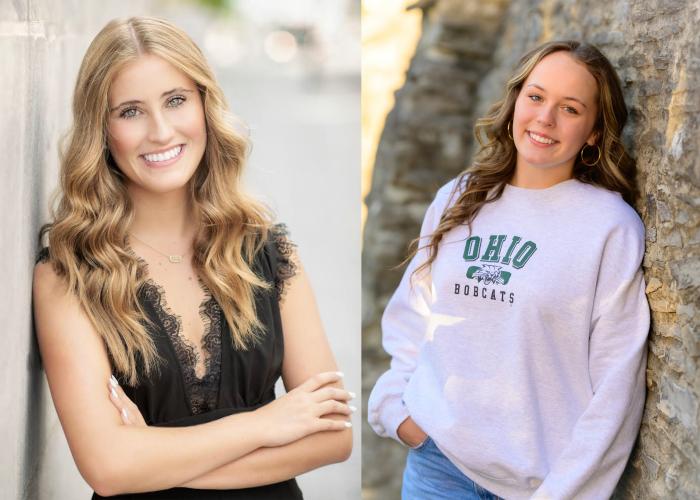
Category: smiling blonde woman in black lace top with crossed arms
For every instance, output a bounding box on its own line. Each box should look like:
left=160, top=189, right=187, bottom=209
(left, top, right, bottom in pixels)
left=34, top=18, right=354, bottom=499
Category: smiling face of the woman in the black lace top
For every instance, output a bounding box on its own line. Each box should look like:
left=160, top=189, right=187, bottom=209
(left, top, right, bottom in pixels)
left=107, top=54, right=207, bottom=193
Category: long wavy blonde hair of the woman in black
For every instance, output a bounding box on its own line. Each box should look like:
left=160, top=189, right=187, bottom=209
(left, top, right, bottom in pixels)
left=39, top=17, right=271, bottom=385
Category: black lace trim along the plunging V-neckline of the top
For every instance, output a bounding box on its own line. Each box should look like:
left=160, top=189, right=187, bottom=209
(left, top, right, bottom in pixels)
left=137, top=256, right=221, bottom=415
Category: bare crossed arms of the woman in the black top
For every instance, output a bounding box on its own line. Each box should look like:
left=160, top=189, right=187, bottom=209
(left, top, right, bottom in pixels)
left=34, top=256, right=352, bottom=496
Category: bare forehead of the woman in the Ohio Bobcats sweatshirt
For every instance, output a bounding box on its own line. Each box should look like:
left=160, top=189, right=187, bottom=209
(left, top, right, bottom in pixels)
left=523, top=51, right=598, bottom=104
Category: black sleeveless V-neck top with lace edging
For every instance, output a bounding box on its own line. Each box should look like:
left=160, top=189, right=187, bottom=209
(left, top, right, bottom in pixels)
left=37, top=225, right=302, bottom=500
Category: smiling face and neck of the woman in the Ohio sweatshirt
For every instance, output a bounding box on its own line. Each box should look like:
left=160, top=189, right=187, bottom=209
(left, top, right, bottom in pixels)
left=512, top=51, right=598, bottom=180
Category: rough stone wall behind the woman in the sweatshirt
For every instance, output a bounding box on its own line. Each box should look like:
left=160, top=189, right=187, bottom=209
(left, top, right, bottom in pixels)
left=363, top=0, right=700, bottom=499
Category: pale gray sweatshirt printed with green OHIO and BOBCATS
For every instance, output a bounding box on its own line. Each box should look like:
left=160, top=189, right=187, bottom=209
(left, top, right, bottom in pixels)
left=368, top=179, right=649, bottom=500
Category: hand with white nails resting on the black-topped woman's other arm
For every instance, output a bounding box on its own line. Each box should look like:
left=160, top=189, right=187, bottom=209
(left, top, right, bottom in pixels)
left=254, top=372, right=355, bottom=447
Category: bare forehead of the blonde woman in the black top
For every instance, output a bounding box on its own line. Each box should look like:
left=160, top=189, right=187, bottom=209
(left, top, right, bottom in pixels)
left=109, top=54, right=194, bottom=106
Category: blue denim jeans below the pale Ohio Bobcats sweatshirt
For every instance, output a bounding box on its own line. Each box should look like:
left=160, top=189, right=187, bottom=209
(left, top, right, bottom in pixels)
left=401, top=438, right=500, bottom=500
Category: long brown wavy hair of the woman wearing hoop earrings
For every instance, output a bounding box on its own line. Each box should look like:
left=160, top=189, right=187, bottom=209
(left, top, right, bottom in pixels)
left=409, top=40, right=638, bottom=274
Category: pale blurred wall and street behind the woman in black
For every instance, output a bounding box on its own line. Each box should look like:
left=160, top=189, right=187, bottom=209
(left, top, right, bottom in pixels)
left=0, top=0, right=361, bottom=500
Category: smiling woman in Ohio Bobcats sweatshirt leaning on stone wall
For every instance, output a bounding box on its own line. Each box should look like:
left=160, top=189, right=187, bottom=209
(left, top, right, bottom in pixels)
left=368, top=41, right=649, bottom=499
